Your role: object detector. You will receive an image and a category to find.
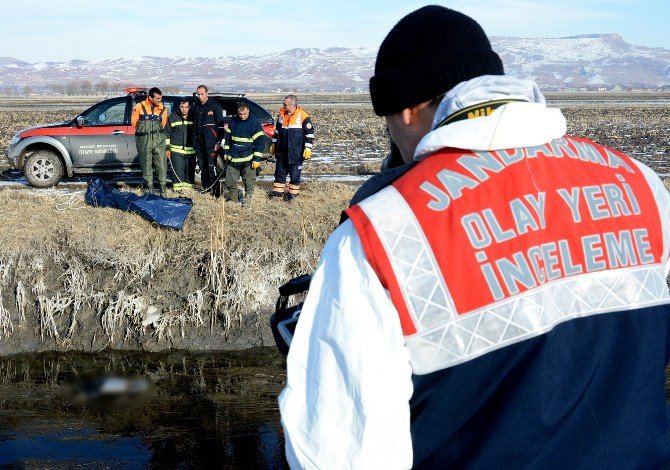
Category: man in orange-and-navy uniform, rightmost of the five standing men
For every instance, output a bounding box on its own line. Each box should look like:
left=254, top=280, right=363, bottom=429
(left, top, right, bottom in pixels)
left=270, top=95, right=314, bottom=201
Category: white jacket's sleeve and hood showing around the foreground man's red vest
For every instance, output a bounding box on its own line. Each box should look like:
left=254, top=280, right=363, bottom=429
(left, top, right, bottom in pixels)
left=279, top=76, right=566, bottom=469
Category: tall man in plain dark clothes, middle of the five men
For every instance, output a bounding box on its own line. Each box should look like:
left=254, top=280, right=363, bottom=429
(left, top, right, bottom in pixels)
left=193, top=85, right=223, bottom=197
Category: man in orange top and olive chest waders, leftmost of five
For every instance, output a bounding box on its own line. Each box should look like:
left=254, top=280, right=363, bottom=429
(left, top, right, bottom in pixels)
left=130, top=87, right=168, bottom=197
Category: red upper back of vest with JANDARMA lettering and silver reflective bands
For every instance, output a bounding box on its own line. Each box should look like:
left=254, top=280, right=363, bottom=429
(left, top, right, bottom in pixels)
left=347, top=136, right=670, bottom=374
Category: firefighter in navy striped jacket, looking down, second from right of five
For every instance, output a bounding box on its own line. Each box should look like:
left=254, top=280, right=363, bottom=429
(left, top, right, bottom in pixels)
left=223, top=103, right=265, bottom=203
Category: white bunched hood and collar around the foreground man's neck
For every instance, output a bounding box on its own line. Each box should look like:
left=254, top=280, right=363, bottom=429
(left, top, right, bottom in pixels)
left=414, top=75, right=566, bottom=161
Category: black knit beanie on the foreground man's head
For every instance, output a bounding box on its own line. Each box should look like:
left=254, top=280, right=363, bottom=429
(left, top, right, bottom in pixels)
left=370, top=5, right=505, bottom=116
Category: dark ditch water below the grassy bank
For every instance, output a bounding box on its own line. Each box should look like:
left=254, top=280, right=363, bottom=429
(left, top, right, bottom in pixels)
left=0, top=348, right=288, bottom=469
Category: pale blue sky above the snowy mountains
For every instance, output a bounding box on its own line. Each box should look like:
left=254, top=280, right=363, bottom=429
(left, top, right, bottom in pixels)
left=5, top=0, right=670, bottom=62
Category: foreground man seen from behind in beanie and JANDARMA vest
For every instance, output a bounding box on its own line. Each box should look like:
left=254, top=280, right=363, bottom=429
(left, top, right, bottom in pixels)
left=279, top=6, right=670, bottom=469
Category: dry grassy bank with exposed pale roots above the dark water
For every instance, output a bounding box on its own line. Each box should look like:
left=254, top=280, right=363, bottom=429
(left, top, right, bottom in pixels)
left=0, top=182, right=354, bottom=355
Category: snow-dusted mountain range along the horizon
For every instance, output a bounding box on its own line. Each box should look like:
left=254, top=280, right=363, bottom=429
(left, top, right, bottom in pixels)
left=0, top=34, right=670, bottom=92
